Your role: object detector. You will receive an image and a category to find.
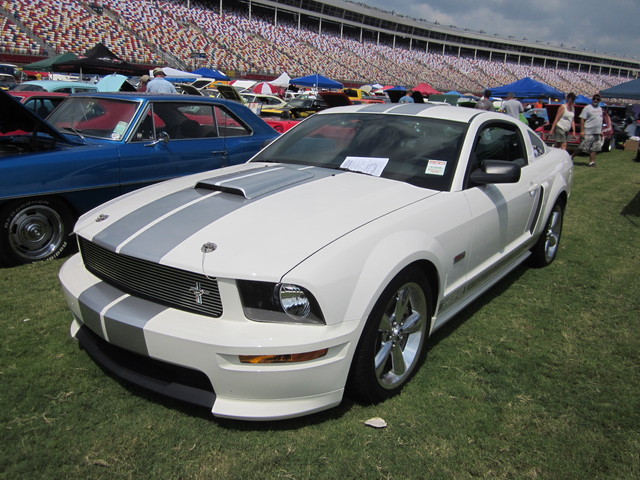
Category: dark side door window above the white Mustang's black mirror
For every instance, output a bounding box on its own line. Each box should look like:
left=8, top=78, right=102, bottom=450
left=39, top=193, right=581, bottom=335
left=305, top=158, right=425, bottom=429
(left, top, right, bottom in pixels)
left=474, top=125, right=527, bottom=167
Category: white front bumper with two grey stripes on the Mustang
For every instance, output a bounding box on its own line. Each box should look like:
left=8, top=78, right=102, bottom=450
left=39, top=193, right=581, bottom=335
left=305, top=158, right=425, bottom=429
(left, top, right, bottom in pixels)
left=60, top=254, right=359, bottom=420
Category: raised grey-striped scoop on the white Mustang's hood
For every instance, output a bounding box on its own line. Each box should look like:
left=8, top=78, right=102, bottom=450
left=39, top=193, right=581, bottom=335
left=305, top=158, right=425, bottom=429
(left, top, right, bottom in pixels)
left=195, top=167, right=315, bottom=200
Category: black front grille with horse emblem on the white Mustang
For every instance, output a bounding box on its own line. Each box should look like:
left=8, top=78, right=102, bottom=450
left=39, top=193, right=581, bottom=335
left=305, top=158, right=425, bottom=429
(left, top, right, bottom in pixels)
left=79, top=237, right=222, bottom=318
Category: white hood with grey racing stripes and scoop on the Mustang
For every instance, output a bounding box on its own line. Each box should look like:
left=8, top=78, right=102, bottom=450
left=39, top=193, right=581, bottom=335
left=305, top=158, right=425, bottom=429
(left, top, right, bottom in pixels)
left=76, top=163, right=437, bottom=281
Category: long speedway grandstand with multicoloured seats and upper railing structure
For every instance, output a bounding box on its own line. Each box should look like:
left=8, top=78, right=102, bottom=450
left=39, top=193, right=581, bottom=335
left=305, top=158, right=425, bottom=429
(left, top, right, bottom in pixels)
left=0, top=0, right=640, bottom=94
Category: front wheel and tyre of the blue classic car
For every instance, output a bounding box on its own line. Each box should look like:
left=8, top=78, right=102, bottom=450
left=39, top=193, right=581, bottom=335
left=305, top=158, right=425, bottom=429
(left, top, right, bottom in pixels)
left=0, top=198, right=73, bottom=266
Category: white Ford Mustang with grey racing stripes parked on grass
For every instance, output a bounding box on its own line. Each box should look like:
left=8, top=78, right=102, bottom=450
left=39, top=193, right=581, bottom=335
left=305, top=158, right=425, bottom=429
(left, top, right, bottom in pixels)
left=60, top=104, right=573, bottom=420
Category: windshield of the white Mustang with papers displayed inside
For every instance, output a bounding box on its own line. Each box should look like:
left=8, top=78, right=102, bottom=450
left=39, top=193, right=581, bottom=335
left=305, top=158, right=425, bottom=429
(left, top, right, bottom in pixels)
left=252, top=113, right=466, bottom=191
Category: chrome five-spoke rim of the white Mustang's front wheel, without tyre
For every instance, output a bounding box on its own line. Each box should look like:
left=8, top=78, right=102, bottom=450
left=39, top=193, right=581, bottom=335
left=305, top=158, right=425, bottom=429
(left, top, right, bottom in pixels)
left=374, top=282, right=429, bottom=389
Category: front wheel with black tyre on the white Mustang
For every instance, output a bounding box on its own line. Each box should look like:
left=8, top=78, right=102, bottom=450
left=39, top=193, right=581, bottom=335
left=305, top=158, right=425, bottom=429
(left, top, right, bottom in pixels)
left=348, top=268, right=431, bottom=403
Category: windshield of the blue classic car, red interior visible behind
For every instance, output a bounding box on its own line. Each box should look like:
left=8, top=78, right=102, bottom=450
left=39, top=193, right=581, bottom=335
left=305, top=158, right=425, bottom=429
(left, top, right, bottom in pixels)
left=47, top=97, right=139, bottom=140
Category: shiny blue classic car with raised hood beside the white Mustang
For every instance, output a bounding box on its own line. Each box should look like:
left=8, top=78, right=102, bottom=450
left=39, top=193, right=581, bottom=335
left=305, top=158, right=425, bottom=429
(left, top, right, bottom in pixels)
left=0, top=92, right=278, bottom=266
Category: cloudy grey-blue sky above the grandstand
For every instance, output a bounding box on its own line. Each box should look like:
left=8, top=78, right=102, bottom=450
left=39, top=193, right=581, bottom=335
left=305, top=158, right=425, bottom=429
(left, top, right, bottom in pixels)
left=359, top=0, right=640, bottom=59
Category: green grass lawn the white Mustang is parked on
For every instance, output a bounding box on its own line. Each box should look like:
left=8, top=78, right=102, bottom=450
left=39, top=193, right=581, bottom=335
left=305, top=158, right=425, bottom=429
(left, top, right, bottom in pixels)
left=0, top=151, right=640, bottom=480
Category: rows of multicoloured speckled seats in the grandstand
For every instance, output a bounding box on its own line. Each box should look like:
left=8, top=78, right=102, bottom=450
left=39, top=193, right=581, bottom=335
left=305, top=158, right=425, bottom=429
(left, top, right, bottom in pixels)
left=0, top=0, right=627, bottom=93
